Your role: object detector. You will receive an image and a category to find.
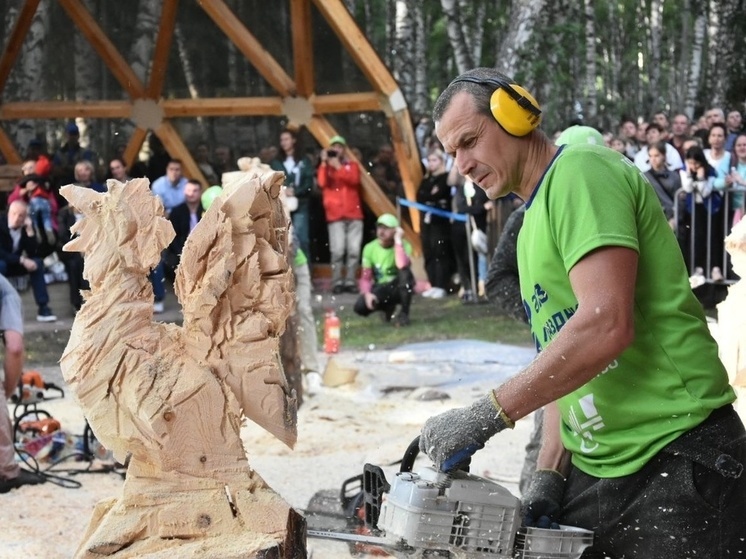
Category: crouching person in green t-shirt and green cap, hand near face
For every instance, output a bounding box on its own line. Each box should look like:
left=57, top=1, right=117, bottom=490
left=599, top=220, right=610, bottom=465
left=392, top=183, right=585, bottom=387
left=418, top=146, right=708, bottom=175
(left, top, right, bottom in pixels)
left=355, top=214, right=415, bottom=326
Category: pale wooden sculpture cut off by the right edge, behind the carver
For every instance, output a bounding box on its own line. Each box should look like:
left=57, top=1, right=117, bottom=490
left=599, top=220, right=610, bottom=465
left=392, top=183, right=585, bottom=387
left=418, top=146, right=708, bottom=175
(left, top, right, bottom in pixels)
left=717, top=219, right=746, bottom=421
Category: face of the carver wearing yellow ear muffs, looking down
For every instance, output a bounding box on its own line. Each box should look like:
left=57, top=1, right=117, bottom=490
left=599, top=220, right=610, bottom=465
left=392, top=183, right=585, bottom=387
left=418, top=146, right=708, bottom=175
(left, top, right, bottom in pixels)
left=435, top=91, right=520, bottom=200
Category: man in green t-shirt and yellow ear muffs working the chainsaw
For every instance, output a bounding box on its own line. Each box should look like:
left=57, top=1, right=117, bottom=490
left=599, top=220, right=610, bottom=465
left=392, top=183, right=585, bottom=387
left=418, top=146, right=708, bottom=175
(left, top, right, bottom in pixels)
left=420, top=68, right=746, bottom=559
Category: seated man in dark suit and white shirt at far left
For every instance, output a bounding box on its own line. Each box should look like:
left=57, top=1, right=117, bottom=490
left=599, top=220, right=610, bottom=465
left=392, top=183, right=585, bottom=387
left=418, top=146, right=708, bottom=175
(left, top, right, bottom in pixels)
left=0, top=200, right=57, bottom=322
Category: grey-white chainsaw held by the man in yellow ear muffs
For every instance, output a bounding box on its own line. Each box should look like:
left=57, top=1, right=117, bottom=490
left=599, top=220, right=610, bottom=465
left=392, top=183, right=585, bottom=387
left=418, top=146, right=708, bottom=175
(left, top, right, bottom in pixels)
left=307, top=437, right=593, bottom=559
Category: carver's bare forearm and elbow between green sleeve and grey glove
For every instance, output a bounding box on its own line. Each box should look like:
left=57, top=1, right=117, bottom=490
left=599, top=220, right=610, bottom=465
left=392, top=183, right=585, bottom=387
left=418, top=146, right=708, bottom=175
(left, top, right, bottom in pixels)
left=495, top=246, right=638, bottom=421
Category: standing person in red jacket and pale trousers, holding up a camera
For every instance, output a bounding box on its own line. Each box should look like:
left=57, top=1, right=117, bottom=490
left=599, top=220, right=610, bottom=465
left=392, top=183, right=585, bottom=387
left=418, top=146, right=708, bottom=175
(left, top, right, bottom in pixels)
left=316, top=136, right=363, bottom=293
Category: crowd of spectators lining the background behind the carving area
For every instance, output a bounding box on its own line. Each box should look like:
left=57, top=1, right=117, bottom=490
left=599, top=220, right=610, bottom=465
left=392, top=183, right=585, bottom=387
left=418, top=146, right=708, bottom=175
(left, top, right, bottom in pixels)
left=0, top=107, right=746, bottom=321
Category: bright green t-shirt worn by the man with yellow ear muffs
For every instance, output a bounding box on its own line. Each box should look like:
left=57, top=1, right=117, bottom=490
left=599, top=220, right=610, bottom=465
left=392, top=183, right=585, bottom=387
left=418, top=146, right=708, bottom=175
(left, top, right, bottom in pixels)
left=518, top=145, right=735, bottom=477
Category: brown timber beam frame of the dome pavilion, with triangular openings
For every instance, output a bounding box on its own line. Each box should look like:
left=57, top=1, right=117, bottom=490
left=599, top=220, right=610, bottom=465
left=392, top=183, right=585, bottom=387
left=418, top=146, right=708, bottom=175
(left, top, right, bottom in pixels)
left=0, top=0, right=422, bottom=247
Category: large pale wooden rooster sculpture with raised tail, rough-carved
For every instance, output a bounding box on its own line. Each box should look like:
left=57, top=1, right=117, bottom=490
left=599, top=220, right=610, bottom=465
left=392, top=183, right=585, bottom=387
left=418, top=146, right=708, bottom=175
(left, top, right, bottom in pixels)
left=61, top=173, right=306, bottom=559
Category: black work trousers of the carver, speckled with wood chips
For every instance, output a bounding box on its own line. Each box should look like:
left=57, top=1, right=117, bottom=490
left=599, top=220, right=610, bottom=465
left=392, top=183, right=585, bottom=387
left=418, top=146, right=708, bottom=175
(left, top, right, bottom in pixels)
left=559, top=406, right=746, bottom=559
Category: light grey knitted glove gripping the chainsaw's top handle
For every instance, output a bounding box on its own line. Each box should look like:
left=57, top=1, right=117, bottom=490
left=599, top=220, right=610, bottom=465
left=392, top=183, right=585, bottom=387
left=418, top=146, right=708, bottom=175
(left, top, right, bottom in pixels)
left=420, top=392, right=513, bottom=472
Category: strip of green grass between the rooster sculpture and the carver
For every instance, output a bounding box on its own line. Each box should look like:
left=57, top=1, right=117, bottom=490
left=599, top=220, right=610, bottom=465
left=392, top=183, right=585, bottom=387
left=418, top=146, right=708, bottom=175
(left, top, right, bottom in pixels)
left=319, top=296, right=531, bottom=349
